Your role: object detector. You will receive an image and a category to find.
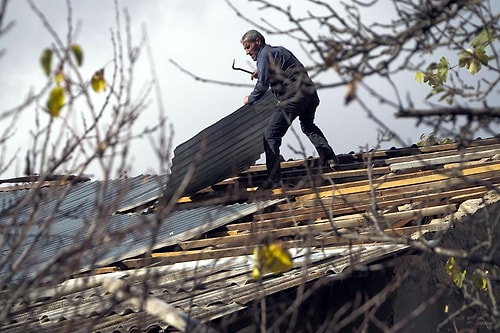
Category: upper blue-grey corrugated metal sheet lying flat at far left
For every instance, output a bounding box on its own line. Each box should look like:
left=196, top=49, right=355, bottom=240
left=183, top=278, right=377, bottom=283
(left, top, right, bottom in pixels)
left=0, top=175, right=164, bottom=281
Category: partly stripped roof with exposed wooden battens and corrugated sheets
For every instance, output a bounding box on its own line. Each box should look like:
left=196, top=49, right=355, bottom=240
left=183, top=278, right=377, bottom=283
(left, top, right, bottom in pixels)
left=0, top=131, right=500, bottom=332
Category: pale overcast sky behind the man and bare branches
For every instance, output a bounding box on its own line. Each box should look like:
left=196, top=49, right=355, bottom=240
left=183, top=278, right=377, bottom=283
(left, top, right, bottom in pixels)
left=0, top=0, right=498, bottom=178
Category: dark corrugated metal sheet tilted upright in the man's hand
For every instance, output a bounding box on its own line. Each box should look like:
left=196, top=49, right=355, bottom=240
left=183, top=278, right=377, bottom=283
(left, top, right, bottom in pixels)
left=166, top=91, right=276, bottom=198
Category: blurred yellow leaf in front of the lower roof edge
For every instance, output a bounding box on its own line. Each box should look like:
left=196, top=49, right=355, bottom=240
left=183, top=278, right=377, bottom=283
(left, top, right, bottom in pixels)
left=252, top=243, right=293, bottom=279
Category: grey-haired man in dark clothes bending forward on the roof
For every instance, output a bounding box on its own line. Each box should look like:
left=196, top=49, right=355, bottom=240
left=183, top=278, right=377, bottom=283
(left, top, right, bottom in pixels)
left=241, top=30, right=338, bottom=188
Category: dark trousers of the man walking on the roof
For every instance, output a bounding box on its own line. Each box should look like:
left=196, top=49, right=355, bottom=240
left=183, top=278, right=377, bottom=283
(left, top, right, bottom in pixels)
left=264, top=92, right=337, bottom=183
